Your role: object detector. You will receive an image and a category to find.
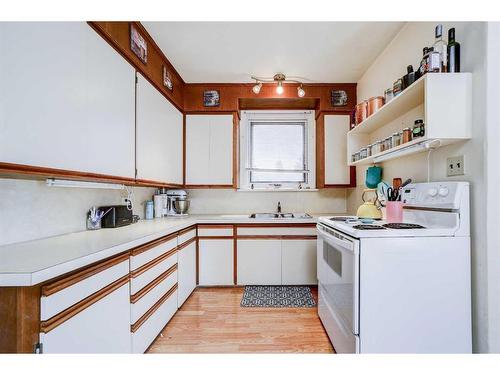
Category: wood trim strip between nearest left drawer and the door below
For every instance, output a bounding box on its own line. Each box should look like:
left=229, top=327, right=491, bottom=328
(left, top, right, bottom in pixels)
left=40, top=275, right=129, bottom=333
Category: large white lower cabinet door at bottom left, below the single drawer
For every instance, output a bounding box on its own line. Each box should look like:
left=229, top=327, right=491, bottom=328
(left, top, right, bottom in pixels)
left=40, top=282, right=130, bottom=353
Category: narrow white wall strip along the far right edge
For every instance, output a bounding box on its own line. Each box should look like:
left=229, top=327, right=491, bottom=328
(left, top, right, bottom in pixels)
left=485, top=22, right=500, bottom=353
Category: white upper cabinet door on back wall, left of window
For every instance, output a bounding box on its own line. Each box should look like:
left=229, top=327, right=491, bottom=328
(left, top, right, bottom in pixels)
left=186, top=115, right=234, bottom=186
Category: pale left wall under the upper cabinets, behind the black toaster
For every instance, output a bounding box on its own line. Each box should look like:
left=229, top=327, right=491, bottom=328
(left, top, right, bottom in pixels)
left=0, top=179, right=154, bottom=245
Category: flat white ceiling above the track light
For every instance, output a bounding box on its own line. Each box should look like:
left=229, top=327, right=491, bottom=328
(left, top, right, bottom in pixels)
left=143, top=22, right=403, bottom=83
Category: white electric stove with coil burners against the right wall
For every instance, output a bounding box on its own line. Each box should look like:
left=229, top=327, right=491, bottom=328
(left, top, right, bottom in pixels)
left=317, top=182, right=471, bottom=353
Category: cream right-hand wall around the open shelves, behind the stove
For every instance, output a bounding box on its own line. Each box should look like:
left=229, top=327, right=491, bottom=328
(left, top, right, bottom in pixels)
left=348, top=22, right=488, bottom=352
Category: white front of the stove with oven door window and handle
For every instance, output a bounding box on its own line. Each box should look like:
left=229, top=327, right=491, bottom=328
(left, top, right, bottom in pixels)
left=317, top=223, right=359, bottom=352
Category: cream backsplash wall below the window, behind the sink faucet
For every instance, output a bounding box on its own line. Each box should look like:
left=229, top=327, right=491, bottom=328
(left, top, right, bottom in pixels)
left=188, top=189, right=346, bottom=214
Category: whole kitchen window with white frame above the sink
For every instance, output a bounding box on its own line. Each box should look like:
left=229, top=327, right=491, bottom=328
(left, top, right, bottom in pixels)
left=240, top=111, right=315, bottom=190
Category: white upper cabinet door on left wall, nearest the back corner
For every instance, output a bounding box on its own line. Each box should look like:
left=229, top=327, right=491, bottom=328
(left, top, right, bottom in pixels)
left=137, top=74, right=183, bottom=184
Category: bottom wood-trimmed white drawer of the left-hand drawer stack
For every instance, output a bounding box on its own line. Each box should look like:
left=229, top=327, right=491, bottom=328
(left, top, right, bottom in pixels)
left=131, top=284, right=177, bottom=353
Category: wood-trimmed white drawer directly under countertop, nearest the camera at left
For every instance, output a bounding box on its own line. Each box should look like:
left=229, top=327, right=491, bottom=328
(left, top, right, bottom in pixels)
left=40, top=253, right=129, bottom=321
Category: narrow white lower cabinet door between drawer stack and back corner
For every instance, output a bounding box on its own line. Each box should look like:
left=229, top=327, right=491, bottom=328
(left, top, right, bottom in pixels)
left=177, top=241, right=196, bottom=307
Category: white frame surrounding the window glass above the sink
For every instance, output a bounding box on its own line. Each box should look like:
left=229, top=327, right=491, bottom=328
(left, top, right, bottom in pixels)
left=239, top=110, right=316, bottom=191
